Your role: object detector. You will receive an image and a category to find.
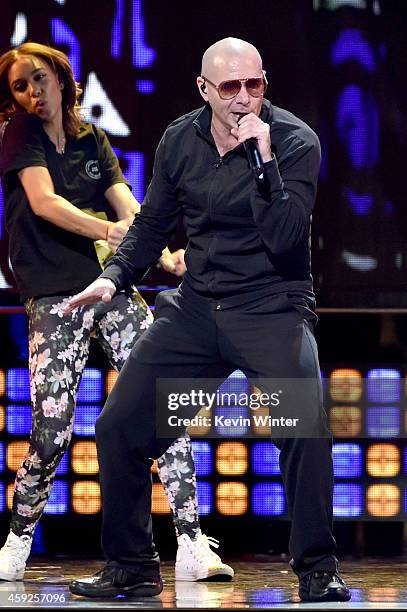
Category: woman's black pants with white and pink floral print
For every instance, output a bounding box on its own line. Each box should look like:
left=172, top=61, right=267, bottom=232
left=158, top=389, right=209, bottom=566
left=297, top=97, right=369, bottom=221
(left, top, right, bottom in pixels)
left=11, top=290, right=199, bottom=539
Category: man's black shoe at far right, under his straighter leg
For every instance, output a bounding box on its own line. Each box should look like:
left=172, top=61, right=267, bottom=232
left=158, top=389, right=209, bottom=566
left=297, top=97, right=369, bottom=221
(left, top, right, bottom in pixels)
left=298, top=571, right=351, bottom=601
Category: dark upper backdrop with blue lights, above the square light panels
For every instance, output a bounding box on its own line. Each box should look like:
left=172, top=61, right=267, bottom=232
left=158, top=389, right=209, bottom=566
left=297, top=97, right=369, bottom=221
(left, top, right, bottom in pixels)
left=0, top=0, right=407, bottom=307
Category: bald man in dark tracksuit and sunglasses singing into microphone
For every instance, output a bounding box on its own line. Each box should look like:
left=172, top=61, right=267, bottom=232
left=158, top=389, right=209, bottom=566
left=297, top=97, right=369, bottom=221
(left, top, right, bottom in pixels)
left=66, top=38, right=350, bottom=601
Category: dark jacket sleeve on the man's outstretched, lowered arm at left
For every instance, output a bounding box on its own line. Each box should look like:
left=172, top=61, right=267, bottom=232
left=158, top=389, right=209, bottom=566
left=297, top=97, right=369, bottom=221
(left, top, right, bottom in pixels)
left=100, top=134, right=181, bottom=289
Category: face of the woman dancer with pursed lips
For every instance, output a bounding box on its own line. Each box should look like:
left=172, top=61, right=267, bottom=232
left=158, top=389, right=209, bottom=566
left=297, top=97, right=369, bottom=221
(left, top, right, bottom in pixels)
left=8, top=55, right=63, bottom=123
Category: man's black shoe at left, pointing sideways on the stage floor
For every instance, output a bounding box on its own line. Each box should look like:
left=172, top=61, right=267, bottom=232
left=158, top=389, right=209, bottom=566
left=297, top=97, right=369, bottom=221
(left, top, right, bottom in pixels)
left=69, top=564, right=163, bottom=597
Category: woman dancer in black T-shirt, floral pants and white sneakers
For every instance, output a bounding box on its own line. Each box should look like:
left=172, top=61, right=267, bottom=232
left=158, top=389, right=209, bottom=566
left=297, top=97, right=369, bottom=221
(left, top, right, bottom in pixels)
left=0, top=43, right=233, bottom=581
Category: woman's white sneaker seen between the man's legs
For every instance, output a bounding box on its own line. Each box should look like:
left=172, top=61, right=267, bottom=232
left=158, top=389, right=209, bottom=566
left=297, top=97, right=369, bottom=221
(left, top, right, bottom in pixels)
left=175, top=531, right=235, bottom=582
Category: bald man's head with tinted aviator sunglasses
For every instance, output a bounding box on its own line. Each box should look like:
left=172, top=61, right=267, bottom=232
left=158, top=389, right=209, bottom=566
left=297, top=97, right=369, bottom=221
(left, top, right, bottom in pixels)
left=197, top=37, right=265, bottom=130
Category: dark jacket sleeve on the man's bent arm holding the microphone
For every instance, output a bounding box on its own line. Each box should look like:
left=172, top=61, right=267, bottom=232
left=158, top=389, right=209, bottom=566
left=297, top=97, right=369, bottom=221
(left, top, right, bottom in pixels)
left=251, top=130, right=321, bottom=255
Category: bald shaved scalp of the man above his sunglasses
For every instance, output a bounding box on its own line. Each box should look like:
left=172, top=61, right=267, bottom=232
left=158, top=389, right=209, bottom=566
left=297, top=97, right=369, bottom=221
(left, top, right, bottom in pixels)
left=201, top=36, right=262, bottom=79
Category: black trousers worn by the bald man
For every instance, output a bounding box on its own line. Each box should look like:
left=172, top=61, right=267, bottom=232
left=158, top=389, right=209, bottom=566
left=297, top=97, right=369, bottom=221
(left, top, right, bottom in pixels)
left=96, top=287, right=337, bottom=576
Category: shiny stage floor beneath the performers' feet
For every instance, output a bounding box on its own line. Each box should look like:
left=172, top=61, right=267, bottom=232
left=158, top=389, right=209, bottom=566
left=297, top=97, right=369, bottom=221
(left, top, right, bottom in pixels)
left=0, top=557, right=407, bottom=610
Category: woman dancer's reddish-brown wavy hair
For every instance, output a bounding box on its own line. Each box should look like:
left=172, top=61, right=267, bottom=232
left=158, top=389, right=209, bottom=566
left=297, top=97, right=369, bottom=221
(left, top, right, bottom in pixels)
left=0, top=42, right=82, bottom=136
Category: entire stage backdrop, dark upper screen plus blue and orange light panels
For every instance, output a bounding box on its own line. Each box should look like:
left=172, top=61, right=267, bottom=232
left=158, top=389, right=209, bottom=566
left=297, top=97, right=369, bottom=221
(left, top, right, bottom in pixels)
left=0, top=0, right=407, bottom=552
